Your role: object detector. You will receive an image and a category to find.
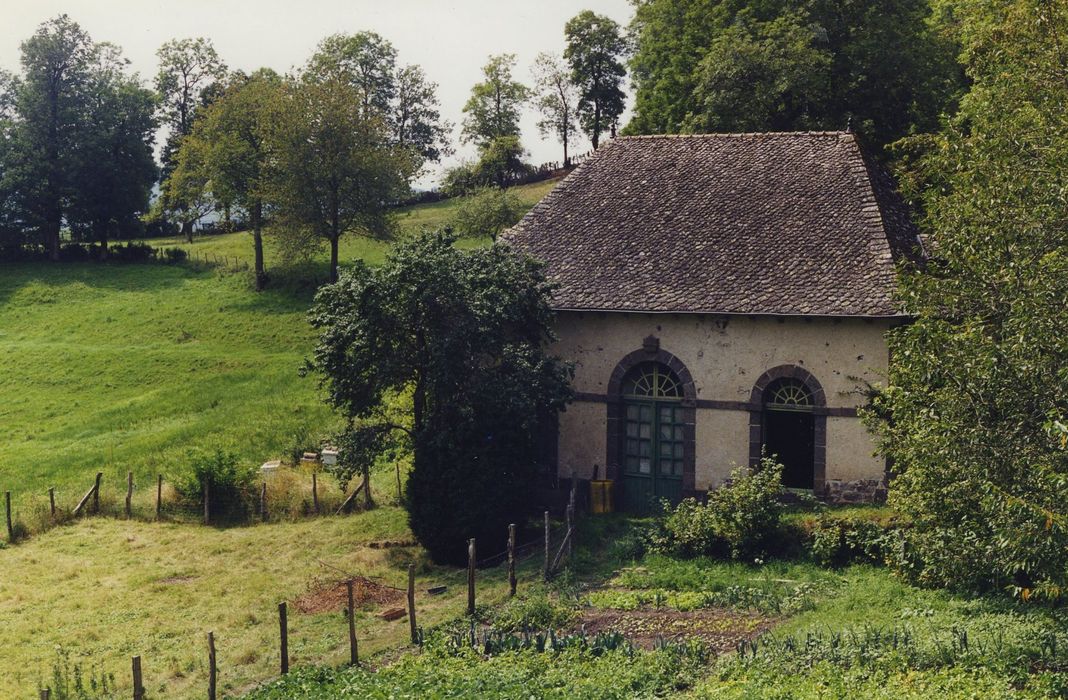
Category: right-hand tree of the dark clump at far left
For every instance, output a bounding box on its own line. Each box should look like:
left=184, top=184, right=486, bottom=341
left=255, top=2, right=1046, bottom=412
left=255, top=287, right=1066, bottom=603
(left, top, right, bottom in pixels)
left=67, top=45, right=157, bottom=259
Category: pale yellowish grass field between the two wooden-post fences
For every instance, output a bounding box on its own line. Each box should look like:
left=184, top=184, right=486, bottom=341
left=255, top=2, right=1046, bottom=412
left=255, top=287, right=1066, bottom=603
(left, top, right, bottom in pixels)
left=0, top=505, right=551, bottom=698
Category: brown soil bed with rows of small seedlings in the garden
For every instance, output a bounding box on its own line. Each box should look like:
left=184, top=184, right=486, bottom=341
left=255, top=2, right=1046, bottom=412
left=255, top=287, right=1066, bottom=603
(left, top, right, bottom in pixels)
left=572, top=608, right=776, bottom=652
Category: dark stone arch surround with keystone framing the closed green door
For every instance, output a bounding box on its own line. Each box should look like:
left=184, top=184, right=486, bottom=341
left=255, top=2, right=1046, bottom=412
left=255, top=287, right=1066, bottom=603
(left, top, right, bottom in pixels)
left=604, top=336, right=697, bottom=498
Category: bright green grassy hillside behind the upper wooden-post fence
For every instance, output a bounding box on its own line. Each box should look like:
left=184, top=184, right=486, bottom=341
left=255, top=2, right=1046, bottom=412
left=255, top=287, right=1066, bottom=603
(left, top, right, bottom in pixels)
left=0, top=182, right=553, bottom=500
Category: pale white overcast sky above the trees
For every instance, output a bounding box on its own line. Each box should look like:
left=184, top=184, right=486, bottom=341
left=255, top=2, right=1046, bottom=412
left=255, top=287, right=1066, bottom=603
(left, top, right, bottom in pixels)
left=0, top=0, right=632, bottom=189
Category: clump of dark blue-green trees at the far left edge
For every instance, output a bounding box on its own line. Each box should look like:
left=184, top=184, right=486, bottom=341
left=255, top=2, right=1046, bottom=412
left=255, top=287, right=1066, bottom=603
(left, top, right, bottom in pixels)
left=0, top=15, right=156, bottom=260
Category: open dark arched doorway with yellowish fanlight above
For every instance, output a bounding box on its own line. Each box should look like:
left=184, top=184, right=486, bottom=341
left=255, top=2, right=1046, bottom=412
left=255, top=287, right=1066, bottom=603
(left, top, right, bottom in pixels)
left=763, top=377, right=816, bottom=489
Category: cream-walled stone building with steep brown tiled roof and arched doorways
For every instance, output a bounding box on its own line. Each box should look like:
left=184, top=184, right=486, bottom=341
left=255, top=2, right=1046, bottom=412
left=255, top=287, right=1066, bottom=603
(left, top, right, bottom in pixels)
left=503, top=133, right=921, bottom=512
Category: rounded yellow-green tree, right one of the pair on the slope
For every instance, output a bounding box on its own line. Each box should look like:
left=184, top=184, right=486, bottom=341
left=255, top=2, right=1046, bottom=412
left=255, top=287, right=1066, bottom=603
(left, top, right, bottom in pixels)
left=269, top=76, right=414, bottom=281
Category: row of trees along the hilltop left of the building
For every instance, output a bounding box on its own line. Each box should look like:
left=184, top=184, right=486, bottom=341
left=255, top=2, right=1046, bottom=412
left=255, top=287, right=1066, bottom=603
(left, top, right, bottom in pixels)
left=0, top=12, right=624, bottom=286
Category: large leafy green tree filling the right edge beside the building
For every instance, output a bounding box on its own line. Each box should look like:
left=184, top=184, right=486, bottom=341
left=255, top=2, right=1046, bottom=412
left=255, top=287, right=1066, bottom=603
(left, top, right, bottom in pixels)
left=868, top=0, right=1068, bottom=600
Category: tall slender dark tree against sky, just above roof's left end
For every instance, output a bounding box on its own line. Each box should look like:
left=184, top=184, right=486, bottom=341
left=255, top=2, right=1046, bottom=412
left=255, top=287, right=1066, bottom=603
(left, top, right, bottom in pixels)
left=564, top=10, right=627, bottom=149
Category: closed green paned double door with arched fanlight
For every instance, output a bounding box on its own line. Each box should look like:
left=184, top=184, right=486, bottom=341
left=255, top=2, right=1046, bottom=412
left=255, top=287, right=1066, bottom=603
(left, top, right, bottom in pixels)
left=621, top=361, right=686, bottom=514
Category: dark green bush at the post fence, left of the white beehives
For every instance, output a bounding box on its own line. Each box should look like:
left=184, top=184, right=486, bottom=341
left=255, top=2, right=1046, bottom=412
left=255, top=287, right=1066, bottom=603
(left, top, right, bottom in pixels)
left=171, top=450, right=255, bottom=519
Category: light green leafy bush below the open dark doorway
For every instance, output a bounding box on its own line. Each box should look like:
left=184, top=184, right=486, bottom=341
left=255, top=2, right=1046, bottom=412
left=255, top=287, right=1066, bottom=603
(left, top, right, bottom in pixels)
left=650, top=457, right=785, bottom=560
